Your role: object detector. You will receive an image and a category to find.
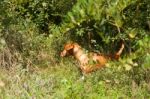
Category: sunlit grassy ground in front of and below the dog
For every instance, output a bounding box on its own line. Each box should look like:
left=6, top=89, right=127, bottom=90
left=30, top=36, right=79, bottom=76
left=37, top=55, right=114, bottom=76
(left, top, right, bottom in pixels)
left=0, top=59, right=150, bottom=99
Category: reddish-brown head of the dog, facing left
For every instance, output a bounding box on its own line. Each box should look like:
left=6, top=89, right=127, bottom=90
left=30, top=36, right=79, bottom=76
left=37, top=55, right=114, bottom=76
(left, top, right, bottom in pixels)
left=60, top=43, right=74, bottom=57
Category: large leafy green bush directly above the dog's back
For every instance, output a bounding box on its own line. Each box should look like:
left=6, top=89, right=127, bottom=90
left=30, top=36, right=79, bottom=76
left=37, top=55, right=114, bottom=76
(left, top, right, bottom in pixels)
left=60, top=0, right=149, bottom=52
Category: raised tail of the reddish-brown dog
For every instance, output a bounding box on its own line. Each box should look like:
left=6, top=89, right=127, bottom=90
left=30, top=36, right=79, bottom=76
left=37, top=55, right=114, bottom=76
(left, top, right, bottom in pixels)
left=110, top=40, right=125, bottom=60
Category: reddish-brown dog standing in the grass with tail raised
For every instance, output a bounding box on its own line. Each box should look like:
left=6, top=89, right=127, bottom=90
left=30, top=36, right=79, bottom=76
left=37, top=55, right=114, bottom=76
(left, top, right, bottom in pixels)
left=61, top=43, right=124, bottom=73
